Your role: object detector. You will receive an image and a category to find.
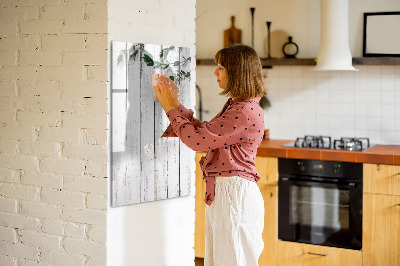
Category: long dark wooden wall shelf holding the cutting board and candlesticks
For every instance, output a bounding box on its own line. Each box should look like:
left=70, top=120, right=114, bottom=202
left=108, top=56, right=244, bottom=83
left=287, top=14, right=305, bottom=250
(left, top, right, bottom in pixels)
left=196, top=57, right=400, bottom=68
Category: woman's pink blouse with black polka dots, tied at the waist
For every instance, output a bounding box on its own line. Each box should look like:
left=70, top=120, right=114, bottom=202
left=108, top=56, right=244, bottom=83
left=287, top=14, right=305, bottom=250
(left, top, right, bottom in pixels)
left=162, top=97, right=265, bottom=205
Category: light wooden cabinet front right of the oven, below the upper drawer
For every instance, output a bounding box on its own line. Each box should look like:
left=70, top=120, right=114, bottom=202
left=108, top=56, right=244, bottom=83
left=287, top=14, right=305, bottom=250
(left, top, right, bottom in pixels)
left=363, top=194, right=400, bottom=266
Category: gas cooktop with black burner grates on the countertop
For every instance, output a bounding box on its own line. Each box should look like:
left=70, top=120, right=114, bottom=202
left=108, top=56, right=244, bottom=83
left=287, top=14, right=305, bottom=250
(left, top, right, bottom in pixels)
left=283, top=135, right=372, bottom=151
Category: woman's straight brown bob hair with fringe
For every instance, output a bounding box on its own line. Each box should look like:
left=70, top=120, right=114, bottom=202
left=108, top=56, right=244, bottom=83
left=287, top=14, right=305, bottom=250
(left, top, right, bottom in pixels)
left=214, top=44, right=267, bottom=99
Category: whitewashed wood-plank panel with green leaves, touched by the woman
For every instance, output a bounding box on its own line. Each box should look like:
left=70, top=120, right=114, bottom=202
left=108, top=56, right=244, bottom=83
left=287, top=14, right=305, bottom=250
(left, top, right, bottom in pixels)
left=110, top=41, right=194, bottom=207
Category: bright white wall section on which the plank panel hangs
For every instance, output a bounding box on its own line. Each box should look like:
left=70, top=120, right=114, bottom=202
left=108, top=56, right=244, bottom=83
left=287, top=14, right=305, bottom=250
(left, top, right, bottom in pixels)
left=107, top=0, right=196, bottom=266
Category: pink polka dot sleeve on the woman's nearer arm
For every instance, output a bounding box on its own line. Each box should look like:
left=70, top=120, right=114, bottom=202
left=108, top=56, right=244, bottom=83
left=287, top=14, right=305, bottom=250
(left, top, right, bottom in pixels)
left=167, top=108, right=248, bottom=151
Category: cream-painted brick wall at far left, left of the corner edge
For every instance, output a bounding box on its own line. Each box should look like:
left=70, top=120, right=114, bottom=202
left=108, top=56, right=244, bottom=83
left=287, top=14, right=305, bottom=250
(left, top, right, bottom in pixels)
left=0, top=0, right=108, bottom=266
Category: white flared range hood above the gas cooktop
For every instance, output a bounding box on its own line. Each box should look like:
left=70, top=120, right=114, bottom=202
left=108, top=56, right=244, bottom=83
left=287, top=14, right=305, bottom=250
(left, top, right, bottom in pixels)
left=314, top=0, right=358, bottom=71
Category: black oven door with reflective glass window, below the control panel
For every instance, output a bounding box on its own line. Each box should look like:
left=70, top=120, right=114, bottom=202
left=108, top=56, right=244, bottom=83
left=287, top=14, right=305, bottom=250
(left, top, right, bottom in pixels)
left=278, top=178, right=362, bottom=249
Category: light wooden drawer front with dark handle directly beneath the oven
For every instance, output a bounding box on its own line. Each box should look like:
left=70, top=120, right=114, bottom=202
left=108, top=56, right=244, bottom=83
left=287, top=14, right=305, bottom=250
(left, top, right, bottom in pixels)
left=276, top=241, right=362, bottom=266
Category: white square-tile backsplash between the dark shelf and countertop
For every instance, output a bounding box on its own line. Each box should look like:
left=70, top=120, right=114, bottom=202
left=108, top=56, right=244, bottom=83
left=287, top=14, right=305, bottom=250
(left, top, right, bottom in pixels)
left=196, top=65, right=400, bottom=144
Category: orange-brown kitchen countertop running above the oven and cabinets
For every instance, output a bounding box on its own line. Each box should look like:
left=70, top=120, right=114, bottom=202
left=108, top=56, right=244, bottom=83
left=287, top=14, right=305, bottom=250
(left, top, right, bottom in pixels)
left=257, top=140, right=400, bottom=165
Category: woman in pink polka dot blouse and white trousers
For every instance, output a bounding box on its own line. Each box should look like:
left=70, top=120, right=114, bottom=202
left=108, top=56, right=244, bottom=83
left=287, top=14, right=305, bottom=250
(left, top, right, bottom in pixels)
left=153, top=45, right=266, bottom=266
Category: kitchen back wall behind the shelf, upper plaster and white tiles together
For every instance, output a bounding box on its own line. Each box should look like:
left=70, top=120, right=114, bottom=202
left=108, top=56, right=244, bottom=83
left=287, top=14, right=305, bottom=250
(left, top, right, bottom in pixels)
left=196, top=0, right=400, bottom=144
